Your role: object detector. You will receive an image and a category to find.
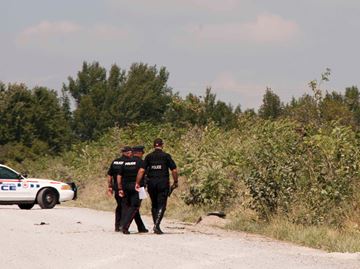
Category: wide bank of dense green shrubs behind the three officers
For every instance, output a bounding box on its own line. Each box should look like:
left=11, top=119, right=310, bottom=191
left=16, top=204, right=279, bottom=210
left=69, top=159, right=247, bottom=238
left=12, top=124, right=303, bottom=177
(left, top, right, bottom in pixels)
left=10, top=121, right=360, bottom=227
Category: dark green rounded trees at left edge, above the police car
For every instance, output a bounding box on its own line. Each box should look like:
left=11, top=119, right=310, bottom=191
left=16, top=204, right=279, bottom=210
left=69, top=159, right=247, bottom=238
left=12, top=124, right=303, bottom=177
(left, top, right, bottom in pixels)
left=0, top=84, right=71, bottom=161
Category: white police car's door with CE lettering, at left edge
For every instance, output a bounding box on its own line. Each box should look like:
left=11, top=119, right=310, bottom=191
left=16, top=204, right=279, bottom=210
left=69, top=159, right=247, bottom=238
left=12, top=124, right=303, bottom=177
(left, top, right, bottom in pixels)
left=0, top=166, right=24, bottom=201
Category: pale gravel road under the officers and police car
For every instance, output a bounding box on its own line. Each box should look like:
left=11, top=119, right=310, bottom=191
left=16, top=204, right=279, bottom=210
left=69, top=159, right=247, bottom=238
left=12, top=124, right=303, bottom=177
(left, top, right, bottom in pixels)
left=0, top=206, right=360, bottom=269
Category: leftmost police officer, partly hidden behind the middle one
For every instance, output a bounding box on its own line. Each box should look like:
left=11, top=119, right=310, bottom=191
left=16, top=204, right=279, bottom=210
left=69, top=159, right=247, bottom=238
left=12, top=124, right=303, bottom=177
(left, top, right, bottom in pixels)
left=107, top=147, right=132, bottom=232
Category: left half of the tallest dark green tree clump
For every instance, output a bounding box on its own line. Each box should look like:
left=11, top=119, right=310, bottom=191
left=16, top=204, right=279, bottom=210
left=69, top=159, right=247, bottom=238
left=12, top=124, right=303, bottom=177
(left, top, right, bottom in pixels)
left=63, top=62, right=116, bottom=140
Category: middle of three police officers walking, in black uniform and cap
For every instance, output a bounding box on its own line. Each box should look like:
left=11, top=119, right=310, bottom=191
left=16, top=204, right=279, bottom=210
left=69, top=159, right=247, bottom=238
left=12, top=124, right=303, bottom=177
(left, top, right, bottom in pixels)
left=117, top=146, right=148, bottom=234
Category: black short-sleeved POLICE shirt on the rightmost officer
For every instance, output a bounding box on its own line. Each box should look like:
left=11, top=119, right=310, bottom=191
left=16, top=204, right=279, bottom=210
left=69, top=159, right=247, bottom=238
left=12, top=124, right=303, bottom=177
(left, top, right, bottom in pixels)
left=145, top=149, right=176, bottom=179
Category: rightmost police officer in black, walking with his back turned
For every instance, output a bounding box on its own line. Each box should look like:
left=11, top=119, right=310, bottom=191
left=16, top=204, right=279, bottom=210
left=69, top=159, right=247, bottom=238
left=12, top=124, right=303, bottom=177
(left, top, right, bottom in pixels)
left=136, top=138, right=178, bottom=234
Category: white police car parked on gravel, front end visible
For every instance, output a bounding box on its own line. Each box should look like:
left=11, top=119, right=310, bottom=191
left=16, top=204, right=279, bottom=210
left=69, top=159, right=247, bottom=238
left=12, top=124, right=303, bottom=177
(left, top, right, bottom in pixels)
left=0, top=164, right=77, bottom=209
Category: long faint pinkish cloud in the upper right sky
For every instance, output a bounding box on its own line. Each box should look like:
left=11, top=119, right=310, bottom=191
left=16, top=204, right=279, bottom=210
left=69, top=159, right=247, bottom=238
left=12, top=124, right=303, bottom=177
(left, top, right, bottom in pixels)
left=179, top=14, right=300, bottom=44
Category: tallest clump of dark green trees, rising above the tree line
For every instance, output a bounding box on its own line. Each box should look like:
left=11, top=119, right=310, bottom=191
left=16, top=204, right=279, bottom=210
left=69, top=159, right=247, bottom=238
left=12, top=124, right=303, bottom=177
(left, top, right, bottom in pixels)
left=63, top=62, right=172, bottom=140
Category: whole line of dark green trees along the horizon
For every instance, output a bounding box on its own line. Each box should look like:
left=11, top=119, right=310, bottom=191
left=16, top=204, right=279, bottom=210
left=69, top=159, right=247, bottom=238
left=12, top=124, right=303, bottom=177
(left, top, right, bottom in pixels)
left=0, top=62, right=360, bottom=162
